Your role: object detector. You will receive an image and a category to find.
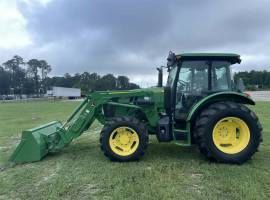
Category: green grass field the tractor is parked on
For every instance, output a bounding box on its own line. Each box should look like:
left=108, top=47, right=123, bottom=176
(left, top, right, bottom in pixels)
left=0, top=102, right=270, bottom=200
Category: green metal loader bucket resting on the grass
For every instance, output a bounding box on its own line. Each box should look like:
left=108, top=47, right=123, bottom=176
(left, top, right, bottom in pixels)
left=10, top=121, right=62, bottom=163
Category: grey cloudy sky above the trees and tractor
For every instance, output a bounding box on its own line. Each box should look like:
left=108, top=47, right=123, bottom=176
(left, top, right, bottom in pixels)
left=0, top=0, right=270, bottom=86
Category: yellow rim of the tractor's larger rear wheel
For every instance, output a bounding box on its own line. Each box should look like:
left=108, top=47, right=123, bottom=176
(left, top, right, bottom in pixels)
left=213, top=117, right=250, bottom=154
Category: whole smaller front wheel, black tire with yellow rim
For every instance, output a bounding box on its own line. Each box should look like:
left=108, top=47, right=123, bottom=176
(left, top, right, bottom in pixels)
left=100, top=117, right=148, bottom=161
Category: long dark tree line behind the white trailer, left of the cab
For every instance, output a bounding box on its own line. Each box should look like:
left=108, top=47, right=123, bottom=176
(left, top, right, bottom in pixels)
left=0, top=55, right=139, bottom=96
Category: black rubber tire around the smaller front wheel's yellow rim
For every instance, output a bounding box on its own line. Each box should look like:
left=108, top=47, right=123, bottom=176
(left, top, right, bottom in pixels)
left=100, top=117, right=149, bottom=162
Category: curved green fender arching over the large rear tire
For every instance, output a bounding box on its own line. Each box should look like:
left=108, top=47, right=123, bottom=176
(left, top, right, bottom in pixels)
left=187, top=92, right=255, bottom=122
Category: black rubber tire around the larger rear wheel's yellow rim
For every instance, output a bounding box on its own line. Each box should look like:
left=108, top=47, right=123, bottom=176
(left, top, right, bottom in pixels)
left=194, top=102, right=262, bottom=164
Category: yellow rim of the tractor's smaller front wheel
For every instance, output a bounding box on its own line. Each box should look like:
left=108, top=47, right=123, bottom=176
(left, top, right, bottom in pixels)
left=109, top=126, right=139, bottom=156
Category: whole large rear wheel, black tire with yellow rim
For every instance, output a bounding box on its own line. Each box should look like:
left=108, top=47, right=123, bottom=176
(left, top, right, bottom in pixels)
left=194, top=102, right=262, bottom=164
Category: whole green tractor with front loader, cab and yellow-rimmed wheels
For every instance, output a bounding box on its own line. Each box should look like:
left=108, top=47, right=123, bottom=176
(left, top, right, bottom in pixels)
left=10, top=52, right=262, bottom=164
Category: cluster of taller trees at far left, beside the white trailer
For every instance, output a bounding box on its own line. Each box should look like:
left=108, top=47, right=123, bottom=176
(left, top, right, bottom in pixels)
left=0, top=55, right=51, bottom=95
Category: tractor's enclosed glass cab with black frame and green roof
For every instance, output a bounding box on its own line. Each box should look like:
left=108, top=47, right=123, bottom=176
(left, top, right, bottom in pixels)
left=166, top=52, right=241, bottom=128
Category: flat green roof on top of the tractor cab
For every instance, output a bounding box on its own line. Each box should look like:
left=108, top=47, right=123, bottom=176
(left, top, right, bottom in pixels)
left=176, top=53, right=241, bottom=64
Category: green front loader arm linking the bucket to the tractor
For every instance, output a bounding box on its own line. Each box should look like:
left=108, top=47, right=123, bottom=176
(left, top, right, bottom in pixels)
left=54, top=91, right=152, bottom=151
